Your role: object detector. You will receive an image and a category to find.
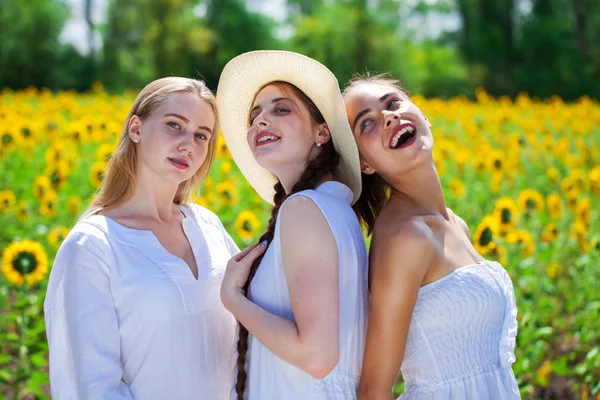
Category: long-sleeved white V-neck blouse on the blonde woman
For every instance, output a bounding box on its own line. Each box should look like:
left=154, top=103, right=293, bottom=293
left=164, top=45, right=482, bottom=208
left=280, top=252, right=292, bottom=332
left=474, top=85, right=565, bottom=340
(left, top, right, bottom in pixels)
left=44, top=204, right=238, bottom=400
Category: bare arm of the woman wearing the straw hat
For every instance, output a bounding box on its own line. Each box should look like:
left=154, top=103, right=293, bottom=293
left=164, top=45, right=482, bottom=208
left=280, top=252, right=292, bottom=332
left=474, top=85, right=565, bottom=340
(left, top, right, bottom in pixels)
left=224, top=196, right=339, bottom=378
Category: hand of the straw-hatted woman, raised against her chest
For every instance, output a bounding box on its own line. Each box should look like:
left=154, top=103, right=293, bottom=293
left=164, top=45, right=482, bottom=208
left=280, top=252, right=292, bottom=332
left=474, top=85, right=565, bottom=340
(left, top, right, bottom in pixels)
left=221, top=241, right=267, bottom=311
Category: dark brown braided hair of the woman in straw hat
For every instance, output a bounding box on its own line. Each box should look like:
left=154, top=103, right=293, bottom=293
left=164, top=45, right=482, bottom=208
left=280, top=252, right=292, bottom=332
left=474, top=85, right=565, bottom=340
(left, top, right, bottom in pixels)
left=235, top=81, right=340, bottom=400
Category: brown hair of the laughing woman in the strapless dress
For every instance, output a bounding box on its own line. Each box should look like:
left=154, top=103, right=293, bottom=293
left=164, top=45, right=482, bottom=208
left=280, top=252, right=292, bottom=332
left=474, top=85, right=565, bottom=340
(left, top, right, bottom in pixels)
left=342, top=73, right=408, bottom=235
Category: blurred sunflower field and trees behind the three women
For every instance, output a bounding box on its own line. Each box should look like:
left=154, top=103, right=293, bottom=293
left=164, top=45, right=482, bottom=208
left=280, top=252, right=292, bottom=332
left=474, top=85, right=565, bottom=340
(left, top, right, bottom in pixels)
left=0, top=0, right=600, bottom=400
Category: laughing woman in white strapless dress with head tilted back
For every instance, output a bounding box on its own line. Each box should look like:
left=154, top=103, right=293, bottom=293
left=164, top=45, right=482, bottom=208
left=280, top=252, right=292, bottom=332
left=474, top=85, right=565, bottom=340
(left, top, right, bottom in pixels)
left=344, top=77, right=519, bottom=400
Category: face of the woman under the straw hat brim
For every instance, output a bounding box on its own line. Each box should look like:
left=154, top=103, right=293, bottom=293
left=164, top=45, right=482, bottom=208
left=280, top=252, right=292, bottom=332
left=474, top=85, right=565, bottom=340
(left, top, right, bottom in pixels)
left=246, top=85, right=329, bottom=180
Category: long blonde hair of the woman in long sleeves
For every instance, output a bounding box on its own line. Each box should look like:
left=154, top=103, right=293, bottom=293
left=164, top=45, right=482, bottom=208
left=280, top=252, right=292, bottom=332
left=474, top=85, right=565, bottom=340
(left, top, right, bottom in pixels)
left=82, top=77, right=219, bottom=218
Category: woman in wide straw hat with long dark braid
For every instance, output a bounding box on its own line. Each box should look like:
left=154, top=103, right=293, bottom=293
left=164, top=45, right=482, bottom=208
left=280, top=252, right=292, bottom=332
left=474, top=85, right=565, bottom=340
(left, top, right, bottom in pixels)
left=217, top=51, right=367, bottom=400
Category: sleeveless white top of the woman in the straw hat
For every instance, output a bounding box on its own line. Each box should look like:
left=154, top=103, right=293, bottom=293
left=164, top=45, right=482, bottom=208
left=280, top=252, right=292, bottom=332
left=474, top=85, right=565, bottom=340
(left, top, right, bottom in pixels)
left=243, top=181, right=368, bottom=400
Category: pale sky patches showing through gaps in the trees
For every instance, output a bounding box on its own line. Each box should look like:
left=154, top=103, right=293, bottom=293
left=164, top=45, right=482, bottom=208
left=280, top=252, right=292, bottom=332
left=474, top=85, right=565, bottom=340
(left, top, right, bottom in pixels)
left=60, top=0, right=460, bottom=54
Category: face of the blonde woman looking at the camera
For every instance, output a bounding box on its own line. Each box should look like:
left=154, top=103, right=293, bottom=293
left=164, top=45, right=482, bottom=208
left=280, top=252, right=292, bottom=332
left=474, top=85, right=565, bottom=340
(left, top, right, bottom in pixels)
left=129, top=92, right=215, bottom=185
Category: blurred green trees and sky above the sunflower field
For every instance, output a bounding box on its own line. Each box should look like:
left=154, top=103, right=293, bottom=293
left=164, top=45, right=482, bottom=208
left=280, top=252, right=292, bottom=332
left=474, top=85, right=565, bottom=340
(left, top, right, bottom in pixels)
left=0, top=0, right=600, bottom=100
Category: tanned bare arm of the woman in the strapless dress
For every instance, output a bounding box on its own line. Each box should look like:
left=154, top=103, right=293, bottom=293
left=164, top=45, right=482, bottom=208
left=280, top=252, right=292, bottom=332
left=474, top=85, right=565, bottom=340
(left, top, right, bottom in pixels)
left=358, top=222, right=435, bottom=400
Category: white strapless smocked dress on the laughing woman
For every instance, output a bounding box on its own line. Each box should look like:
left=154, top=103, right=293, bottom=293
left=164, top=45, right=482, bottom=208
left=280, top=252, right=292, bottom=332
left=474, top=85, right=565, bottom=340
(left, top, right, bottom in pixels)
left=399, top=261, right=520, bottom=400
